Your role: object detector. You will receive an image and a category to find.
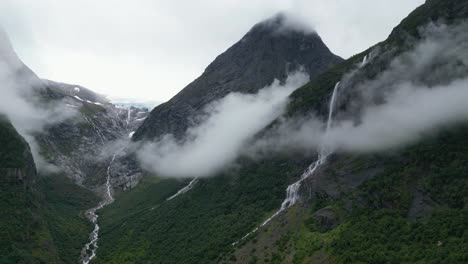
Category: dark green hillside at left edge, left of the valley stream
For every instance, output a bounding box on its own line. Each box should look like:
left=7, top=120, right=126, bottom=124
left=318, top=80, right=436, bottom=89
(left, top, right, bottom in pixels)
left=0, top=117, right=97, bottom=263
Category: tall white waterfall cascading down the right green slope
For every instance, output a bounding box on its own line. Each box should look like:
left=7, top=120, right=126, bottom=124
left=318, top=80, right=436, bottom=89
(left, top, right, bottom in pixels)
left=232, top=82, right=340, bottom=246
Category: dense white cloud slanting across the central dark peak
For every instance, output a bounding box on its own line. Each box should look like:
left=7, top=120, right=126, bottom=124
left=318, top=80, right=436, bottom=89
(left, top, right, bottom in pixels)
left=137, top=72, right=309, bottom=177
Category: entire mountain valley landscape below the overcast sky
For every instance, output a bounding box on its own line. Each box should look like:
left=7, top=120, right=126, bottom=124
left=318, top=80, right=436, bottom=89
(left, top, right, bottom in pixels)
left=0, top=0, right=468, bottom=264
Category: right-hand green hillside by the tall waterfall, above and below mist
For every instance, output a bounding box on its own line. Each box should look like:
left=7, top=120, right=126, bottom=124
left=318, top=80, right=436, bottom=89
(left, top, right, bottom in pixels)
left=228, top=1, right=468, bottom=263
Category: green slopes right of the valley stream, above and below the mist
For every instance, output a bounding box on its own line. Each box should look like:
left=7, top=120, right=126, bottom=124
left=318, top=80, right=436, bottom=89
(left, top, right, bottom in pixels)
left=97, top=1, right=468, bottom=263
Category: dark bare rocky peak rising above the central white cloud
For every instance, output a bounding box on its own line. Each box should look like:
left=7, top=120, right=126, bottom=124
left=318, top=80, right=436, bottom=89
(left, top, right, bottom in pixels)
left=133, top=14, right=342, bottom=140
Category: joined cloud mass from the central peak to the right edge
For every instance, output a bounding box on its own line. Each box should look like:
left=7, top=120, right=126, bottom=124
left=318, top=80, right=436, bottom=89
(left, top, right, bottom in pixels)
left=138, top=21, right=468, bottom=177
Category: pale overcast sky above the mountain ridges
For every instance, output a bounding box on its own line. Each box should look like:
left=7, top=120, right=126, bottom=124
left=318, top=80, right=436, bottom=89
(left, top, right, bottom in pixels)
left=0, top=0, right=424, bottom=101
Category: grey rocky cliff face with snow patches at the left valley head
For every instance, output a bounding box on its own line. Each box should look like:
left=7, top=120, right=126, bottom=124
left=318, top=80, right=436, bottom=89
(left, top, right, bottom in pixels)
left=37, top=81, right=148, bottom=188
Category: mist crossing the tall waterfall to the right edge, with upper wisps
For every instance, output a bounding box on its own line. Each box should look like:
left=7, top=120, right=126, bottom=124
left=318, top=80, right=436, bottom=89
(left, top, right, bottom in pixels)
left=258, top=23, right=468, bottom=157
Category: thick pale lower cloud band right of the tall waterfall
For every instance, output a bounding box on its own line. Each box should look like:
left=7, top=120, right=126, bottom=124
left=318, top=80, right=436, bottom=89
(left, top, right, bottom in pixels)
left=327, top=79, right=468, bottom=152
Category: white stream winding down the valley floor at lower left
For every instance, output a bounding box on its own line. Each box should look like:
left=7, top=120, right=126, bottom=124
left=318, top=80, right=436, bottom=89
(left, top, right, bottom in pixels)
left=81, top=154, right=117, bottom=264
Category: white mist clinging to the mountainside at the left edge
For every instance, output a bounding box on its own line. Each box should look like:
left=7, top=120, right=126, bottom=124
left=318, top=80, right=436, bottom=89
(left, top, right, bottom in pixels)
left=0, top=28, right=76, bottom=172
